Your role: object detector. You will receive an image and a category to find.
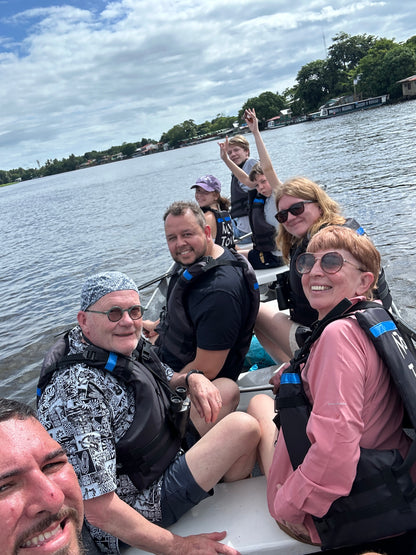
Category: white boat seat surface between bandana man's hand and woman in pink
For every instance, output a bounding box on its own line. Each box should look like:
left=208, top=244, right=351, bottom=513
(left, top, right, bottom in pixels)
left=123, top=476, right=321, bottom=555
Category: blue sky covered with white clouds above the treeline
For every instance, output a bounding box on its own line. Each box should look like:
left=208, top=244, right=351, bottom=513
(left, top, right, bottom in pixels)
left=0, top=0, right=416, bottom=170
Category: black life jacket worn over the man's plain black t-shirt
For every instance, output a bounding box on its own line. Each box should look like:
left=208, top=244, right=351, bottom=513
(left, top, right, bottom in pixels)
left=155, top=249, right=260, bottom=379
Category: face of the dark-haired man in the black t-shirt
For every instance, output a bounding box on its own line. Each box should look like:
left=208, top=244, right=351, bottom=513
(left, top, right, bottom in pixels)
left=165, top=210, right=211, bottom=266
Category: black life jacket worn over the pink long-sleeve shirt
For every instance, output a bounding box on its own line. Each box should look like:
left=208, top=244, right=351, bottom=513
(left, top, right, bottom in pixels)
left=275, top=299, right=416, bottom=549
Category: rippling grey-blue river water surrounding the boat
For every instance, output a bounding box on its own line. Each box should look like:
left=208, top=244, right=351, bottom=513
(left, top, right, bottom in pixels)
left=0, top=101, right=416, bottom=402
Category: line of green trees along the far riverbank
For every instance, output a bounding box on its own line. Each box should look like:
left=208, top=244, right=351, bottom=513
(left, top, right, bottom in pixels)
left=0, top=32, right=416, bottom=184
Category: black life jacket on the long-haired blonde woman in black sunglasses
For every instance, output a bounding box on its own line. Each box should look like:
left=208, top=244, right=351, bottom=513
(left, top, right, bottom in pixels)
left=288, top=218, right=392, bottom=326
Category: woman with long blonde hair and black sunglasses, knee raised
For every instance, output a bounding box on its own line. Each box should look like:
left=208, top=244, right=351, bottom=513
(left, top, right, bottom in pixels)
left=255, top=177, right=374, bottom=361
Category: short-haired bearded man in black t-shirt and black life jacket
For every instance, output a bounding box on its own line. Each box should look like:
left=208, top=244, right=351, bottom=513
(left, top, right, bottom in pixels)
left=143, top=202, right=259, bottom=436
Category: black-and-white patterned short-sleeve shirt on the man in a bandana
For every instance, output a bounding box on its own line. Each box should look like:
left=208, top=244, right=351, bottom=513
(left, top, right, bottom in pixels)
left=38, top=326, right=173, bottom=553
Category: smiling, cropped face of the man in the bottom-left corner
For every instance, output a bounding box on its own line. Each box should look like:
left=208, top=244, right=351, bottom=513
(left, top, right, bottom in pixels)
left=0, top=418, right=84, bottom=555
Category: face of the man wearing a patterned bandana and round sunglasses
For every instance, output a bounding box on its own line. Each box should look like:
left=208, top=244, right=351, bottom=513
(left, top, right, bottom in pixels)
left=78, top=289, right=143, bottom=356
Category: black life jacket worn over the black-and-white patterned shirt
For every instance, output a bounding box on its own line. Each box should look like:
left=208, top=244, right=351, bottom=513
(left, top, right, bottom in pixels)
left=37, top=334, right=185, bottom=490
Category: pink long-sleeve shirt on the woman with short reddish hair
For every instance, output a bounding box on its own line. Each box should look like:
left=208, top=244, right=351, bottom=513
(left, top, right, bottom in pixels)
left=267, top=299, right=410, bottom=543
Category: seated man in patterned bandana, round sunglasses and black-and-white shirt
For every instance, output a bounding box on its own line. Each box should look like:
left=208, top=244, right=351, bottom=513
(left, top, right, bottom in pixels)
left=38, top=272, right=259, bottom=555
